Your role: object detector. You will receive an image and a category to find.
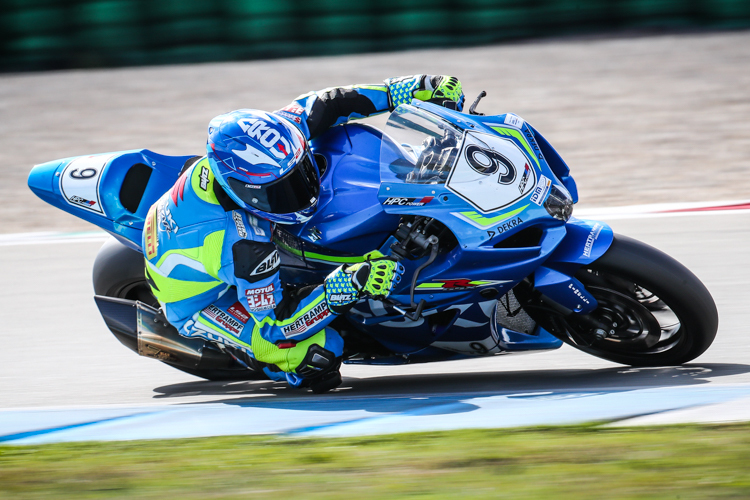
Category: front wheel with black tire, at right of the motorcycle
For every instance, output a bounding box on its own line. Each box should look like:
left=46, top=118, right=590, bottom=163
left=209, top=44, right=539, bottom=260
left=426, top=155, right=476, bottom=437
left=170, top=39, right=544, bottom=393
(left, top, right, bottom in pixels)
left=558, top=235, right=719, bottom=366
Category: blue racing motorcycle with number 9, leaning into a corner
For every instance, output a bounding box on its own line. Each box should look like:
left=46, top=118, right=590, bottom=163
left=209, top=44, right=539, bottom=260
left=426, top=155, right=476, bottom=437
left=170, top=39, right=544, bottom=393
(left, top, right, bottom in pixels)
left=29, top=92, right=718, bottom=380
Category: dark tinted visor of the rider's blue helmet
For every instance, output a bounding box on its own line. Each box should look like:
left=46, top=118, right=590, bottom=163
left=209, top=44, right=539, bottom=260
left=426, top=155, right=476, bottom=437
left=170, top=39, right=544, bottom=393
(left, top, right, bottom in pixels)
left=227, top=151, right=320, bottom=214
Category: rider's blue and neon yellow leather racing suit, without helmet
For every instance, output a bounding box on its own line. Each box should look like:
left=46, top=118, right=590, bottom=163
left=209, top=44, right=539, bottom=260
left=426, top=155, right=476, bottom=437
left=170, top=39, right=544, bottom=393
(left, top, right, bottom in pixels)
left=143, top=75, right=462, bottom=377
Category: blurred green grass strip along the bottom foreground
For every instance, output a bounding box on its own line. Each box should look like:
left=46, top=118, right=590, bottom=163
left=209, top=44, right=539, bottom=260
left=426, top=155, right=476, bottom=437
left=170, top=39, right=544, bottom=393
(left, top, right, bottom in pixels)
left=0, top=423, right=750, bottom=500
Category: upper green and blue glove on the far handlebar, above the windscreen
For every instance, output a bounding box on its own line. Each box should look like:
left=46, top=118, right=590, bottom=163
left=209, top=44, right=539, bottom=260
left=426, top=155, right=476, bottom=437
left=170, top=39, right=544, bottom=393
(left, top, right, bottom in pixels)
left=385, top=75, right=465, bottom=111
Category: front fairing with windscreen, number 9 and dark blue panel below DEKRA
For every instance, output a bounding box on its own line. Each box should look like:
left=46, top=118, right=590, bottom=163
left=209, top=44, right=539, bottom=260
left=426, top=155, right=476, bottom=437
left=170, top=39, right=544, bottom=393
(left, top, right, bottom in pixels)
left=378, top=101, right=580, bottom=299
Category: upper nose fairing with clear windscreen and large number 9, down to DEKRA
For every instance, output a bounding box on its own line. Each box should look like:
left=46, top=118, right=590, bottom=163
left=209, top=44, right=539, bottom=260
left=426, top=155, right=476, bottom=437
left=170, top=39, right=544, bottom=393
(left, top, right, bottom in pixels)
left=378, top=101, right=568, bottom=249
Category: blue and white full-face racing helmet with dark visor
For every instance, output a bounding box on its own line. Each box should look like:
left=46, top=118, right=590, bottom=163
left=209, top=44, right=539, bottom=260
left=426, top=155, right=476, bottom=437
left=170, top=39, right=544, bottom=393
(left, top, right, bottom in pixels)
left=206, top=109, right=320, bottom=224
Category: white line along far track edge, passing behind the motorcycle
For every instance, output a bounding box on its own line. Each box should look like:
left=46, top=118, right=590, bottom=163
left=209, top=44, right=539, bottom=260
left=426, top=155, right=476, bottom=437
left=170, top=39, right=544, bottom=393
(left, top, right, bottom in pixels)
left=0, top=200, right=750, bottom=246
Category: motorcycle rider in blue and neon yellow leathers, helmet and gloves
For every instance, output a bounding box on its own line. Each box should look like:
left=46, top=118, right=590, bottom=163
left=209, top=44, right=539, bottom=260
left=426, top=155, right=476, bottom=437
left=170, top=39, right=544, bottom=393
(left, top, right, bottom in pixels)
left=143, top=75, right=464, bottom=392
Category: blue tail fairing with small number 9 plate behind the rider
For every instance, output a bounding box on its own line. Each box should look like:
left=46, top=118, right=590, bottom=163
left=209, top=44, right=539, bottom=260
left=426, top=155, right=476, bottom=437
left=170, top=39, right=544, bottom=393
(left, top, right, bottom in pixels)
left=28, top=149, right=192, bottom=251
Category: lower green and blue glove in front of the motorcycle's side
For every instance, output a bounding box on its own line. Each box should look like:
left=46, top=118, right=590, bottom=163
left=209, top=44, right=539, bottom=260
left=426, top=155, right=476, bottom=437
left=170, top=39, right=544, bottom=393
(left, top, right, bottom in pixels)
left=325, top=258, right=404, bottom=314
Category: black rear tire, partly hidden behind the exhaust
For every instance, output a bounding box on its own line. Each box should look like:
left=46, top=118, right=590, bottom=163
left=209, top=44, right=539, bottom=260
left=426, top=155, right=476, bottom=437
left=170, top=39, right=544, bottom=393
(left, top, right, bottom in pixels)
left=93, top=238, right=268, bottom=381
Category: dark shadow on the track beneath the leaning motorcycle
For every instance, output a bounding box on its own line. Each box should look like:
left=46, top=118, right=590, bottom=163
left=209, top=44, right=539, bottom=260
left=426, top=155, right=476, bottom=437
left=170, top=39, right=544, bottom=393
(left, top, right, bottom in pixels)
left=154, top=363, right=750, bottom=404
